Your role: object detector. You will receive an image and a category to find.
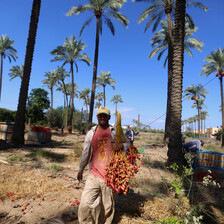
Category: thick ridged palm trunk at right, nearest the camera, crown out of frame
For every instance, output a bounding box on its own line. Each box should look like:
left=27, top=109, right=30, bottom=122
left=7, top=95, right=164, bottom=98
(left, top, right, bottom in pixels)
left=167, top=0, right=186, bottom=165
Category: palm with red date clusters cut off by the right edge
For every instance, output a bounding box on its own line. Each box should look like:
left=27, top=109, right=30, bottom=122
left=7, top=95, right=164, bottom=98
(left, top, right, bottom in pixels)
left=200, top=48, right=224, bottom=147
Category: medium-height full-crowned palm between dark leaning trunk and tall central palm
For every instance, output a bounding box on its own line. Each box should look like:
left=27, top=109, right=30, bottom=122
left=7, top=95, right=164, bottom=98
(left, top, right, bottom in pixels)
left=51, top=36, right=91, bottom=130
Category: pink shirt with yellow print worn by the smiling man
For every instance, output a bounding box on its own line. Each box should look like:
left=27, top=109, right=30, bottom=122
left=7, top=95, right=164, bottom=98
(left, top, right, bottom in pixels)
left=90, top=128, right=113, bottom=180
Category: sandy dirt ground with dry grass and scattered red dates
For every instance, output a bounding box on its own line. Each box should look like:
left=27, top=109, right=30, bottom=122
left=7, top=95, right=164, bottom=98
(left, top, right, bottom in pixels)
left=0, top=132, right=224, bottom=224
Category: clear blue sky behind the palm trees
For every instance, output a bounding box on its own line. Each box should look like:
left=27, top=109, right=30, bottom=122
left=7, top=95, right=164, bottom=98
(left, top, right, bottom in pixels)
left=0, top=0, right=224, bottom=129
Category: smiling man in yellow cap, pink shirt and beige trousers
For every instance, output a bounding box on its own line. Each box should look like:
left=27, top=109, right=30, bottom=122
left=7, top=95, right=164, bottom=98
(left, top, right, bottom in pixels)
left=77, top=107, right=129, bottom=224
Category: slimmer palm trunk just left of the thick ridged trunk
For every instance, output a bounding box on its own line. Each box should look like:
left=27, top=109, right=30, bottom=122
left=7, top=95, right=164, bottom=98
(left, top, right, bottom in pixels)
left=164, top=9, right=173, bottom=141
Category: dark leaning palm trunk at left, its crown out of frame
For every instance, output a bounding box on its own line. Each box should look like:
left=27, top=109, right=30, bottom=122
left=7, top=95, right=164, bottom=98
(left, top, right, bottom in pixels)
left=12, top=0, right=41, bottom=144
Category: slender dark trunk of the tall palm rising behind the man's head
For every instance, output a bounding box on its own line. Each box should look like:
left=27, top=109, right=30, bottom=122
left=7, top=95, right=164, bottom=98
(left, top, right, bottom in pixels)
left=88, top=17, right=100, bottom=129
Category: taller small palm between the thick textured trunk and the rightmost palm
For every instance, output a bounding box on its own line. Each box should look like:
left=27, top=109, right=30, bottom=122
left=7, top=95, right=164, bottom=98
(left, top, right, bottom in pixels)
left=184, top=84, right=208, bottom=138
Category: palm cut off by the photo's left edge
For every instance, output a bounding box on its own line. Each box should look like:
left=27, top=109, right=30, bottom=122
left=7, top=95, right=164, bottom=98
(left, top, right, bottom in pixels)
left=0, top=35, right=18, bottom=99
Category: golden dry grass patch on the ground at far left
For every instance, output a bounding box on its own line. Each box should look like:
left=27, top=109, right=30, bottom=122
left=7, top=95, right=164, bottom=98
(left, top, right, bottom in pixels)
left=0, top=164, right=66, bottom=200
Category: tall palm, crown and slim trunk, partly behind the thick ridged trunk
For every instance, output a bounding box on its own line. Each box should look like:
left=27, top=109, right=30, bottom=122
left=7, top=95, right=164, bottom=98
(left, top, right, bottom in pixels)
left=133, top=0, right=207, bottom=140
